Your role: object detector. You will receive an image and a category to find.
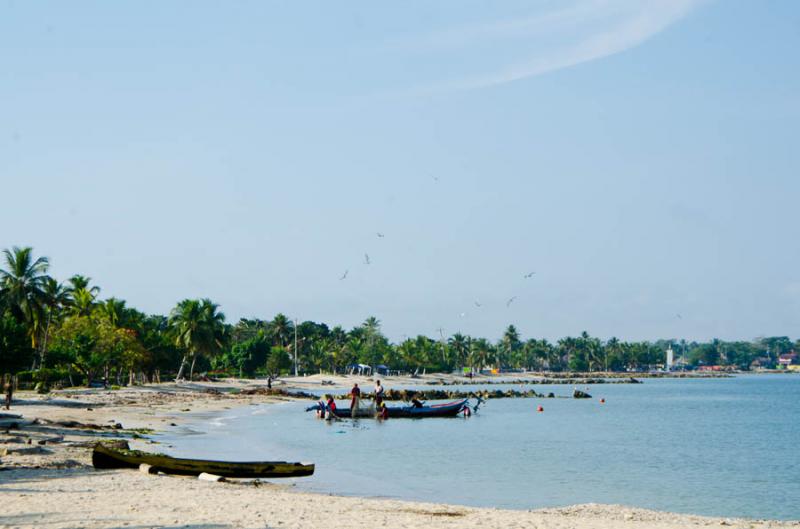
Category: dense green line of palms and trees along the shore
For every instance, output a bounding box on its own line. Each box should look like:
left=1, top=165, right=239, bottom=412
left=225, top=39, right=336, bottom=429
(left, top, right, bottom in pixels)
left=0, top=247, right=800, bottom=384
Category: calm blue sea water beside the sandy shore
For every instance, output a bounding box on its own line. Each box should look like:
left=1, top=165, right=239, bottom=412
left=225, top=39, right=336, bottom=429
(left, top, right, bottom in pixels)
left=158, top=375, right=800, bottom=519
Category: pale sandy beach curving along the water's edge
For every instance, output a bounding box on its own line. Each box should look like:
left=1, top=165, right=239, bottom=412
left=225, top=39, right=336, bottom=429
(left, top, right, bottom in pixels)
left=0, top=376, right=800, bottom=529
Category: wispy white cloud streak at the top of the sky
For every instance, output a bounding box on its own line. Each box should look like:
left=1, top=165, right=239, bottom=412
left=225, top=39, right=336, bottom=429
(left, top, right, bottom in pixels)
left=395, top=0, right=707, bottom=93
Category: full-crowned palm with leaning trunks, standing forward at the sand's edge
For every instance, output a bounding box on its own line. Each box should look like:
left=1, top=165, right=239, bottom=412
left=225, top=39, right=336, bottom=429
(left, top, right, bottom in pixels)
left=169, top=299, right=225, bottom=380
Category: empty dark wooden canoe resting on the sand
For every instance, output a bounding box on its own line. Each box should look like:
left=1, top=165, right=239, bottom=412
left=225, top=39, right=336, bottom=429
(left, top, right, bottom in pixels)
left=92, top=443, right=314, bottom=478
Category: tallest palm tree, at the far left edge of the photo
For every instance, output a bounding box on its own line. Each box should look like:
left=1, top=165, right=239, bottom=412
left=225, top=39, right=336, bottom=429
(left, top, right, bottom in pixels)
left=0, top=246, right=50, bottom=356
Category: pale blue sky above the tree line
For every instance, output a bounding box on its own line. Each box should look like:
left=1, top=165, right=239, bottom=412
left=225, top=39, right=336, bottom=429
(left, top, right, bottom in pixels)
left=0, top=0, right=800, bottom=339
